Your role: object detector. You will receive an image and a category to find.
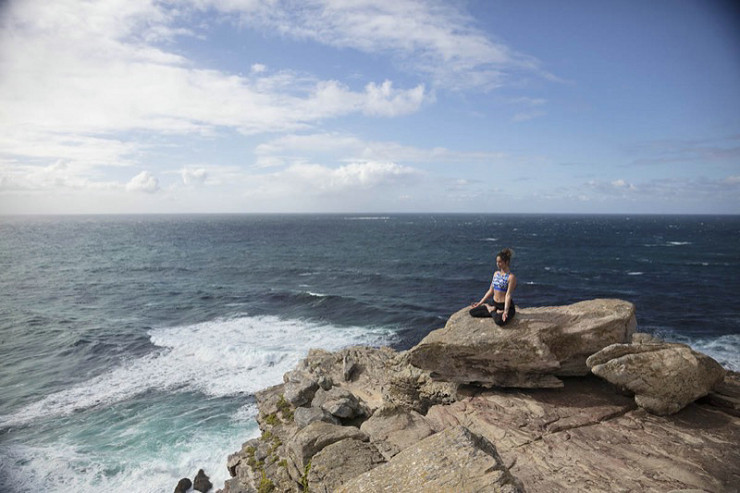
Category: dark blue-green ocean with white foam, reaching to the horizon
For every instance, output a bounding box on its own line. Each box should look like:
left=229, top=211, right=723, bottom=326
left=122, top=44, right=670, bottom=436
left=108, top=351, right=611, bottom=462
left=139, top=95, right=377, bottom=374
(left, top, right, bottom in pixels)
left=0, top=214, right=740, bottom=493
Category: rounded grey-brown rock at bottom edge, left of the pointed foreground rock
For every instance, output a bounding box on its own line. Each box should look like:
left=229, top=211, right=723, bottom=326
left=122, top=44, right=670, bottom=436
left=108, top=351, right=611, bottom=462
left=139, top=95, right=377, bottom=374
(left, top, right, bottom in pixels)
left=307, top=438, right=385, bottom=493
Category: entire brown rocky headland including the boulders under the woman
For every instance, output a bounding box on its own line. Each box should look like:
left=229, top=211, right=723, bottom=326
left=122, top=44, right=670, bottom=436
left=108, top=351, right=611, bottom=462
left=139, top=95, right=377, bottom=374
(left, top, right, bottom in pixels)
left=205, top=300, right=740, bottom=493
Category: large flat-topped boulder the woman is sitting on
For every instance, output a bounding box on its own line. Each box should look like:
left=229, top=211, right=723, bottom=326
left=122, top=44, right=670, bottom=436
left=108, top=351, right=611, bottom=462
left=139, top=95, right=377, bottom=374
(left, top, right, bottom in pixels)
left=408, top=299, right=636, bottom=388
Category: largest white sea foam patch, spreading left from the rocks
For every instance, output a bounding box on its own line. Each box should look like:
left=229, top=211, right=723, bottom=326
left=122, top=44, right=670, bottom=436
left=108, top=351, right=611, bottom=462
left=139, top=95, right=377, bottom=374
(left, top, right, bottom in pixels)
left=0, top=316, right=394, bottom=426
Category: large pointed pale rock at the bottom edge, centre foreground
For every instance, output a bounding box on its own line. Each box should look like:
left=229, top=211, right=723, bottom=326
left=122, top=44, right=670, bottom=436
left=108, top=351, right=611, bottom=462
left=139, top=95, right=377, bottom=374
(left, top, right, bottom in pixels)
left=336, top=426, right=523, bottom=493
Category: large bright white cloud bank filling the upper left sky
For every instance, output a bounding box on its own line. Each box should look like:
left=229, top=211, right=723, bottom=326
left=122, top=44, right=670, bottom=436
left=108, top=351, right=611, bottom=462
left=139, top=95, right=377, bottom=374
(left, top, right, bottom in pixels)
left=0, top=0, right=428, bottom=173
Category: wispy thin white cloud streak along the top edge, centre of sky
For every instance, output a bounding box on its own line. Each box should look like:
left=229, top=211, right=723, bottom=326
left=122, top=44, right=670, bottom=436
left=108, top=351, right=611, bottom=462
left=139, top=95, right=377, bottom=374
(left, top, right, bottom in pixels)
left=195, top=0, right=554, bottom=89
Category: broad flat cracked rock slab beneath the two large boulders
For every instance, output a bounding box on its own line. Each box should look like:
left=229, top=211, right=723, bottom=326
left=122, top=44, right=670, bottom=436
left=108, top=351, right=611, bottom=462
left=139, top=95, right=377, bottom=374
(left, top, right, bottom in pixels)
left=426, top=377, right=740, bottom=492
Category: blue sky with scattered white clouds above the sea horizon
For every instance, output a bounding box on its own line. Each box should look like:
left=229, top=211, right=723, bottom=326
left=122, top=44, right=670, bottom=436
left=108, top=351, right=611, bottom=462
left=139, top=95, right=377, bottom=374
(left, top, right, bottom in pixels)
left=0, top=0, right=740, bottom=214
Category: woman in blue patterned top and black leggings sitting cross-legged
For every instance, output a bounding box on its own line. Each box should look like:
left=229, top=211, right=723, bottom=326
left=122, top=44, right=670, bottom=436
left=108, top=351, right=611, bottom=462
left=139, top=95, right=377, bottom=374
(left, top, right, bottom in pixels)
left=470, top=248, right=516, bottom=326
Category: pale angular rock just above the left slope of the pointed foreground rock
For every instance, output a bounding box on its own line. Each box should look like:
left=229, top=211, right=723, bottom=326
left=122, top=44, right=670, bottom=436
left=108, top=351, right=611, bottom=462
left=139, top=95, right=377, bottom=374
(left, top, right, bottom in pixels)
left=360, top=409, right=434, bottom=460
